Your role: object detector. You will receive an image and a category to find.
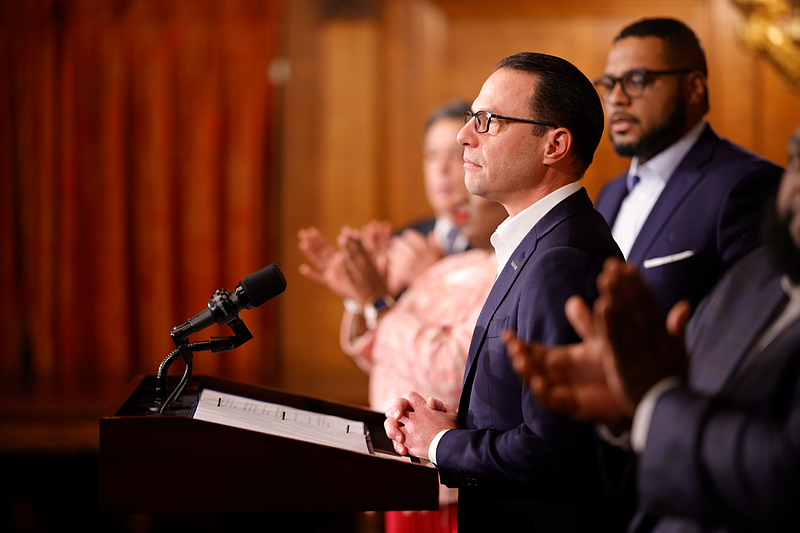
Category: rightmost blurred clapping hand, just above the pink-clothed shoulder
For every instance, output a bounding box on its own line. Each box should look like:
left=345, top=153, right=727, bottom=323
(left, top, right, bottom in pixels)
left=387, top=229, right=444, bottom=295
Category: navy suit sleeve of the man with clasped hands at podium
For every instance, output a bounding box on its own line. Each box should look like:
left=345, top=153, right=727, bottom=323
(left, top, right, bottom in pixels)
left=437, top=247, right=600, bottom=486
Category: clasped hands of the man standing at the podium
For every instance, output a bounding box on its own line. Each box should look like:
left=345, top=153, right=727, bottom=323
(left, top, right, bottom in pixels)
left=383, top=392, right=458, bottom=459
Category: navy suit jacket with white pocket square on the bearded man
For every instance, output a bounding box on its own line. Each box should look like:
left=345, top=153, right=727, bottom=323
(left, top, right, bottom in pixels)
left=596, top=126, right=782, bottom=312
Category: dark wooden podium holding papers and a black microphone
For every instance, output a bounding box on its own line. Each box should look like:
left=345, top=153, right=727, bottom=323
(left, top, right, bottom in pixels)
left=100, top=375, right=439, bottom=514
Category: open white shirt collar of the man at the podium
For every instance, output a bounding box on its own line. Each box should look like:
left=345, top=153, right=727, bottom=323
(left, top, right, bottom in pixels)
left=491, top=180, right=581, bottom=276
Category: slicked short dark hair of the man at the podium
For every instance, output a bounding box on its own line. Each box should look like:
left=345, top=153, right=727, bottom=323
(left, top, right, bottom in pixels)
left=497, top=52, right=604, bottom=176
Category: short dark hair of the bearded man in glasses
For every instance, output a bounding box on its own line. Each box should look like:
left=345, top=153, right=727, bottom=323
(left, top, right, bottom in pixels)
left=614, top=18, right=708, bottom=76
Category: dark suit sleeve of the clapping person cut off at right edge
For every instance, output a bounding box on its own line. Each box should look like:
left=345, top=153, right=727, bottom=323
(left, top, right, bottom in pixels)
left=637, top=376, right=800, bottom=531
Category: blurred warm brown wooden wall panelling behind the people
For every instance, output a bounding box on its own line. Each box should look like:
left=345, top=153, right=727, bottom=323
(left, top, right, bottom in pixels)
left=278, top=0, right=800, bottom=403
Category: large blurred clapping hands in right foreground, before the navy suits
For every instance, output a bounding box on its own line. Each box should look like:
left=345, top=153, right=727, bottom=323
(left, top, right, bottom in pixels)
left=504, top=259, right=689, bottom=424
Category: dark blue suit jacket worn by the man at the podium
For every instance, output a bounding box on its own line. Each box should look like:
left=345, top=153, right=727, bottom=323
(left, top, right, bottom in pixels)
left=436, top=189, right=621, bottom=531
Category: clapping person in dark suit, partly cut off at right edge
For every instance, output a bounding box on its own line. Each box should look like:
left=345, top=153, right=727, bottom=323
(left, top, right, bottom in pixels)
left=506, top=120, right=800, bottom=532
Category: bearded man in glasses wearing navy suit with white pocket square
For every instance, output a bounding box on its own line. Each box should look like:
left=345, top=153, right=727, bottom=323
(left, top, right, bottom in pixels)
left=594, top=19, right=781, bottom=309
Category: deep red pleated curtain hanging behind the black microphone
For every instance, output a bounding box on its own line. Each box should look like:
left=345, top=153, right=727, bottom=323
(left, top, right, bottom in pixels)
left=0, top=0, right=283, bottom=397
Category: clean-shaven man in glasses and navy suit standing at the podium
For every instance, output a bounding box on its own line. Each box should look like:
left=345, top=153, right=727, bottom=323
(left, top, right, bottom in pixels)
left=385, top=53, right=621, bottom=531
